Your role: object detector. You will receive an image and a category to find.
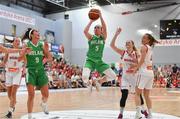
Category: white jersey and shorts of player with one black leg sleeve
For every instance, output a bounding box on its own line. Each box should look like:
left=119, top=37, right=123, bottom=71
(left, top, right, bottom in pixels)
left=121, top=51, right=138, bottom=92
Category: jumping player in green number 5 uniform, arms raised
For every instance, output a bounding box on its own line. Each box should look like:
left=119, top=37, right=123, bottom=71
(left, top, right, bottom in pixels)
left=82, top=11, right=116, bottom=90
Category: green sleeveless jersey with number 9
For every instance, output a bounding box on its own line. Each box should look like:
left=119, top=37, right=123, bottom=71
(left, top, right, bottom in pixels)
left=26, top=41, right=44, bottom=68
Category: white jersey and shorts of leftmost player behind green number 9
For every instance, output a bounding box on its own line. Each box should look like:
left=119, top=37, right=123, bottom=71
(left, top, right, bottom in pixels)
left=5, top=53, right=23, bottom=86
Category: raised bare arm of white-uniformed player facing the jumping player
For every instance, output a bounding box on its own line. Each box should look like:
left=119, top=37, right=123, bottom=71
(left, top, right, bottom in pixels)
left=110, top=28, right=124, bottom=55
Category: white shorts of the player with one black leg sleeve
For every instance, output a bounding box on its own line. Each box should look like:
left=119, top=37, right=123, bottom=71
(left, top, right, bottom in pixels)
left=121, top=74, right=137, bottom=93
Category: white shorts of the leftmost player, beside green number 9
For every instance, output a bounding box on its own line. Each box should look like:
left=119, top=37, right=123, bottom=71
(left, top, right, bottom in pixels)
left=6, top=71, right=22, bottom=86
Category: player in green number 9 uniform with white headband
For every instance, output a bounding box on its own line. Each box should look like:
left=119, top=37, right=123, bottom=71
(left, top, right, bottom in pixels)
left=23, top=29, right=52, bottom=119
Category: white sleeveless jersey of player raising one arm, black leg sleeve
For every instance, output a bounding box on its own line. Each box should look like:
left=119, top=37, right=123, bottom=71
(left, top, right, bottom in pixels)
left=122, top=51, right=138, bottom=74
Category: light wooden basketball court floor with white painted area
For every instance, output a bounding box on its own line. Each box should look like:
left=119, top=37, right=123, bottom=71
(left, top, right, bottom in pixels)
left=0, top=87, right=180, bottom=119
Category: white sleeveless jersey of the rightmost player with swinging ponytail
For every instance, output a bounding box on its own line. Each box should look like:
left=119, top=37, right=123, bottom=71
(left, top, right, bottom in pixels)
left=139, top=45, right=153, bottom=76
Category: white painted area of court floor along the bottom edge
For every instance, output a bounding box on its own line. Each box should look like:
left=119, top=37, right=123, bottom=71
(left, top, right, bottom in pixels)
left=21, top=110, right=180, bottom=119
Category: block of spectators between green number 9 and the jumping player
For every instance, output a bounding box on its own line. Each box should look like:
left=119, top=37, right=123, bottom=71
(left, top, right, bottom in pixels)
left=46, top=59, right=86, bottom=89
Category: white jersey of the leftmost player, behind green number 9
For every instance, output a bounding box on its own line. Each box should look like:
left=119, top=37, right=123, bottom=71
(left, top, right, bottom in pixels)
left=6, top=53, right=23, bottom=71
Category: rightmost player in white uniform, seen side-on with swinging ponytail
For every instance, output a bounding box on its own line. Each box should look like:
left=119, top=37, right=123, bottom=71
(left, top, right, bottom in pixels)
left=134, top=34, right=158, bottom=119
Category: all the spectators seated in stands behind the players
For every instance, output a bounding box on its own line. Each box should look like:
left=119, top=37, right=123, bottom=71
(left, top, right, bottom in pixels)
left=0, top=58, right=180, bottom=92
